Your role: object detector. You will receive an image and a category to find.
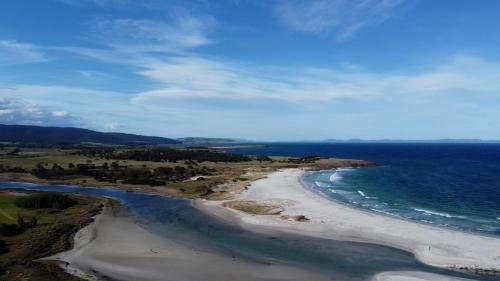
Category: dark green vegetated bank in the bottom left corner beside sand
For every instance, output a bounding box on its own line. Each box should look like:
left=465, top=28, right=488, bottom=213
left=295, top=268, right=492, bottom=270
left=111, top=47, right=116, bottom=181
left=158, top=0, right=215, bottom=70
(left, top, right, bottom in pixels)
left=0, top=191, right=106, bottom=281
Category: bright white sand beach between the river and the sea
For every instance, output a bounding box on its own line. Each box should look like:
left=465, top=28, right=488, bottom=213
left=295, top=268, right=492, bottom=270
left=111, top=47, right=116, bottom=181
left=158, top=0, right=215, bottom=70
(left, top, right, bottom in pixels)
left=195, top=169, right=500, bottom=270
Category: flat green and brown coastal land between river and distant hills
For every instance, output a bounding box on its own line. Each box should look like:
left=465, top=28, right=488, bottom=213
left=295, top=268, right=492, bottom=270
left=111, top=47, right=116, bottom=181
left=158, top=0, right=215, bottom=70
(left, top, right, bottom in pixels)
left=0, top=145, right=373, bottom=198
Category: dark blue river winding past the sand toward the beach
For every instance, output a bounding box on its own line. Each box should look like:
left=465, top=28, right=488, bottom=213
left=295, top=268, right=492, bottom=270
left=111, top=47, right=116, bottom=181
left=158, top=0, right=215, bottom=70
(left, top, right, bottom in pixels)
left=0, top=182, right=494, bottom=280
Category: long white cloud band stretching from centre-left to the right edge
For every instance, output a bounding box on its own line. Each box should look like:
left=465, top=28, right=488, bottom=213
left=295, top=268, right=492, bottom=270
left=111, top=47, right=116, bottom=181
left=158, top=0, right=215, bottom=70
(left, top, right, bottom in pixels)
left=132, top=53, right=500, bottom=103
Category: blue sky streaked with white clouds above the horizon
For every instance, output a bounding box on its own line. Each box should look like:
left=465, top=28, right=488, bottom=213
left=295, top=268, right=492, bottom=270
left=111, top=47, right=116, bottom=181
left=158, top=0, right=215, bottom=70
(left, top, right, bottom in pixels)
left=0, top=0, right=500, bottom=141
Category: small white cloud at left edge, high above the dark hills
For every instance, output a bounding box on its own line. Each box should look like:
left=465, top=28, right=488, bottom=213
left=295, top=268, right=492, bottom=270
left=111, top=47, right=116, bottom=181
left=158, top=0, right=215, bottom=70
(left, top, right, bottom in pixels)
left=0, top=40, right=47, bottom=65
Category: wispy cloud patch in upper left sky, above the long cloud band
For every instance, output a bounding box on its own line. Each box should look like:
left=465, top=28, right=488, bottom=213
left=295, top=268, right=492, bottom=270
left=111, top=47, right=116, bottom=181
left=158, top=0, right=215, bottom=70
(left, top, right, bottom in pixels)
left=55, top=12, right=216, bottom=66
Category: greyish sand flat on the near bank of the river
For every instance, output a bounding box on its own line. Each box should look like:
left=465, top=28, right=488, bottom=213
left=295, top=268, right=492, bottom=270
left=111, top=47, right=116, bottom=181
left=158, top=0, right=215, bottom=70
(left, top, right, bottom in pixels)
left=45, top=205, right=336, bottom=281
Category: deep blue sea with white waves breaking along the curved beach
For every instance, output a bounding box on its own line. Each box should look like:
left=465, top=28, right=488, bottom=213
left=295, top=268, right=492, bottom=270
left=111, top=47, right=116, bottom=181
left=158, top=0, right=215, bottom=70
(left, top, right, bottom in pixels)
left=230, top=143, right=500, bottom=236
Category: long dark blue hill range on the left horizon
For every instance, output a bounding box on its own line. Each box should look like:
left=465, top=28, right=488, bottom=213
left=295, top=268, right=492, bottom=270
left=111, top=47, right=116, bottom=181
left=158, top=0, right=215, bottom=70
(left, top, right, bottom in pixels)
left=0, top=124, right=180, bottom=145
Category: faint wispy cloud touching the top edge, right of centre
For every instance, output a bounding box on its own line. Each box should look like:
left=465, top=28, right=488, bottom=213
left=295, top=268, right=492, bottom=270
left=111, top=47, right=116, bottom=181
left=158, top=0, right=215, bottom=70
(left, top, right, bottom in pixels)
left=275, top=0, right=413, bottom=39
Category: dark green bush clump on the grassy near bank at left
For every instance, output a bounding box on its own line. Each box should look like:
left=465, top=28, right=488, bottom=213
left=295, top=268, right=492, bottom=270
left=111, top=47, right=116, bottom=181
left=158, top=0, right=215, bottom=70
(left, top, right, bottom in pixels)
left=16, top=193, right=76, bottom=210
